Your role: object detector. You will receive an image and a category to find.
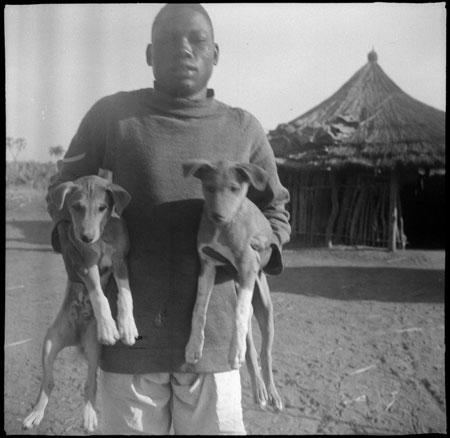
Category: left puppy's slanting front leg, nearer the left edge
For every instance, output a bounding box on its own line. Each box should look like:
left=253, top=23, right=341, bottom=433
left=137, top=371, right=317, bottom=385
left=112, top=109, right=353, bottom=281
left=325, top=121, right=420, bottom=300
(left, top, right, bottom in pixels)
left=82, top=265, right=120, bottom=345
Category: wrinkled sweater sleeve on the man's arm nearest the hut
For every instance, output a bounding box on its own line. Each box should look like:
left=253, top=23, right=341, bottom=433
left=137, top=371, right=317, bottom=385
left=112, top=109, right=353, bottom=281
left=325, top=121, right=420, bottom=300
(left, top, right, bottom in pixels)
left=244, top=112, right=291, bottom=275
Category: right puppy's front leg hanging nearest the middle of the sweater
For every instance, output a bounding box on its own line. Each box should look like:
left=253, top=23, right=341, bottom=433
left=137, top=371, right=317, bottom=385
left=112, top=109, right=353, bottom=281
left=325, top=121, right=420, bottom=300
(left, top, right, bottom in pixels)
left=185, top=257, right=216, bottom=364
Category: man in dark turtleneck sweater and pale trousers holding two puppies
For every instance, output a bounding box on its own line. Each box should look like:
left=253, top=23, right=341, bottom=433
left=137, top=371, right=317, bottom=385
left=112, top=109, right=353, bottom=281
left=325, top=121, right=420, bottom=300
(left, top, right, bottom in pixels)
left=48, top=4, right=290, bottom=435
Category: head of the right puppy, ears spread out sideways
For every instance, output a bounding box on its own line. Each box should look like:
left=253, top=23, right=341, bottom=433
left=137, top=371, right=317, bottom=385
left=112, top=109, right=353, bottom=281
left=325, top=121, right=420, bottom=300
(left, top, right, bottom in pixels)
left=183, top=159, right=268, bottom=225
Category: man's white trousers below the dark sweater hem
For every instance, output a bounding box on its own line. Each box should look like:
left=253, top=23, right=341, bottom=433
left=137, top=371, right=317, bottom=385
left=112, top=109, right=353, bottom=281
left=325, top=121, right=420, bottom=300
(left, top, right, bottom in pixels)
left=99, top=370, right=246, bottom=435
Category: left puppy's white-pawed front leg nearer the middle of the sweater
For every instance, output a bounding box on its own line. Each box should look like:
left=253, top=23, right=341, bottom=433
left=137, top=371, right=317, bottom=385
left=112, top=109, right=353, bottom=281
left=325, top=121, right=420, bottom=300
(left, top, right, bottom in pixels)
left=113, top=259, right=139, bottom=345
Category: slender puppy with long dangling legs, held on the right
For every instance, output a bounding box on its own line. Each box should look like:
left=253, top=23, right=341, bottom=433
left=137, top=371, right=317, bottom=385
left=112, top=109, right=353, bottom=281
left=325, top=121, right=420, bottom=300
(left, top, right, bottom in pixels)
left=183, top=159, right=282, bottom=410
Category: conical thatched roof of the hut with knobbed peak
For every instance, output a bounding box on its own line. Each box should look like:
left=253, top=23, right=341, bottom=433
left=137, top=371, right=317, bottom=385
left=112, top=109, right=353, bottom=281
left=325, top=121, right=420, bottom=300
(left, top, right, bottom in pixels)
left=269, top=51, right=445, bottom=170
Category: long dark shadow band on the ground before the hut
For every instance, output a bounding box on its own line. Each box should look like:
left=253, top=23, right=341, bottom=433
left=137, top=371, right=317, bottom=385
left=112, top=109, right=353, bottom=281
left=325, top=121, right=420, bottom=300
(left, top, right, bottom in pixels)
left=269, top=266, right=445, bottom=303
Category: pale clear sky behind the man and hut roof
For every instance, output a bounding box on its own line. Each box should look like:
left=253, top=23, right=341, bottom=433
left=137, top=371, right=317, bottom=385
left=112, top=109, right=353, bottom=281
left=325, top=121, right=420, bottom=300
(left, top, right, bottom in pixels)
left=4, top=2, right=447, bottom=161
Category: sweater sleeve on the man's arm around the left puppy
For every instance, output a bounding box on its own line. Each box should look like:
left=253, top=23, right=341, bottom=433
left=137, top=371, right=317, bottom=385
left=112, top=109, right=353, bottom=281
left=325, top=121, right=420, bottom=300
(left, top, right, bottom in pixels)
left=46, top=101, right=105, bottom=252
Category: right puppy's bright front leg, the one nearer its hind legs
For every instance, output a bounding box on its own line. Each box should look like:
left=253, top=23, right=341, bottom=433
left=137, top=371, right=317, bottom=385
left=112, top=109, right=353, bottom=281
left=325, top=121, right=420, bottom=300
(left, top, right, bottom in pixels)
left=228, top=250, right=258, bottom=369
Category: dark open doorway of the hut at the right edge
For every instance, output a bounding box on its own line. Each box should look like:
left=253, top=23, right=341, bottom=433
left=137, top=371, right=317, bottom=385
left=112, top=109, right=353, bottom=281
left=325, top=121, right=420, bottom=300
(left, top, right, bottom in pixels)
left=400, top=175, right=445, bottom=249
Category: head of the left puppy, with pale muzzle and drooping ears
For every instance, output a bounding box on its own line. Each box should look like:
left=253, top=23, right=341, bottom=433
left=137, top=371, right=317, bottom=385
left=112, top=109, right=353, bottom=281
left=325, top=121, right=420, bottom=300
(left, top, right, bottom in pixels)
left=50, top=176, right=131, bottom=243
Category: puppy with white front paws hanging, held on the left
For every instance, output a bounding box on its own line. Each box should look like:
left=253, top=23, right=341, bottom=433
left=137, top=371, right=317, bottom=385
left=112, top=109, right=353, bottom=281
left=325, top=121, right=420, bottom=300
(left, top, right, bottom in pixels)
left=22, top=173, right=138, bottom=432
